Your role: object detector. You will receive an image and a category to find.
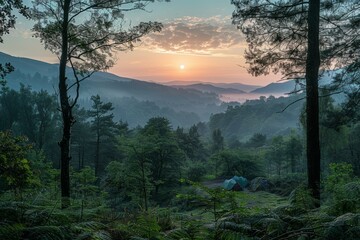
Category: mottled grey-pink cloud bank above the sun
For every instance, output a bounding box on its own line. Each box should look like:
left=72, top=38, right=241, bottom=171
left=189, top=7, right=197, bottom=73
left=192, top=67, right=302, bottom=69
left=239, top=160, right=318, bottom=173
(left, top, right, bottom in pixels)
left=143, top=16, right=244, bottom=55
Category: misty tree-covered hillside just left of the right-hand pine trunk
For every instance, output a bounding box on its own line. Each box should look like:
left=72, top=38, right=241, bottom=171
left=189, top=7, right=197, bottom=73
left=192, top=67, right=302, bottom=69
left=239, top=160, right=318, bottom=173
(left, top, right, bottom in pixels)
left=209, top=93, right=304, bottom=141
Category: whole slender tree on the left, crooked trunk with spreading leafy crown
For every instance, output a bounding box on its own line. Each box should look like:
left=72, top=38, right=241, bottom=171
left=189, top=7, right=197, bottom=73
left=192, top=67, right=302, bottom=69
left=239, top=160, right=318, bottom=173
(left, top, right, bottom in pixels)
left=32, top=0, right=166, bottom=208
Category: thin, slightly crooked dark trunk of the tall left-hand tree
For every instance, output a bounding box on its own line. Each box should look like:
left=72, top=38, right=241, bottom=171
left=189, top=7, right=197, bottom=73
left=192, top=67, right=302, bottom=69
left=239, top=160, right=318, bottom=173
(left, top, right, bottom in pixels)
left=59, top=0, right=70, bottom=209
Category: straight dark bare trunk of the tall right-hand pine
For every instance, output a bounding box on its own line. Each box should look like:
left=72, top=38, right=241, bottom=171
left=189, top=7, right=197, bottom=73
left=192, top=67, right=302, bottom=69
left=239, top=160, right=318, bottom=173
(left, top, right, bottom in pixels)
left=306, top=0, right=320, bottom=207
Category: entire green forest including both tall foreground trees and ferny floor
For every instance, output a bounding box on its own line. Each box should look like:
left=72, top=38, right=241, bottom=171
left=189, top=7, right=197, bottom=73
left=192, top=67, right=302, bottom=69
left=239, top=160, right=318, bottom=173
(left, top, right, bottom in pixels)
left=0, top=0, right=360, bottom=240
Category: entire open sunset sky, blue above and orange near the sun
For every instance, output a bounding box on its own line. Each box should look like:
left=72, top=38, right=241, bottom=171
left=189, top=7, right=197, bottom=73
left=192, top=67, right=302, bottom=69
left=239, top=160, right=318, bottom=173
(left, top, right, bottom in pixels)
left=0, top=0, right=279, bottom=85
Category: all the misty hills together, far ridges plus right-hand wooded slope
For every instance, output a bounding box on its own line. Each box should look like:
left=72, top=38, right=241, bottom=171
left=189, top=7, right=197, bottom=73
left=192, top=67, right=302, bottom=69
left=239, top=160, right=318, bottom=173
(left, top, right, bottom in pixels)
left=0, top=52, right=344, bottom=140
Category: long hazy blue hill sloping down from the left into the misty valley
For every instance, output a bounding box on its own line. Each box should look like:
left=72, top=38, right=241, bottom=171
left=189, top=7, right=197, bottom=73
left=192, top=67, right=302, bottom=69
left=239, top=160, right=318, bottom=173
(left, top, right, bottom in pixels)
left=0, top=53, right=224, bottom=126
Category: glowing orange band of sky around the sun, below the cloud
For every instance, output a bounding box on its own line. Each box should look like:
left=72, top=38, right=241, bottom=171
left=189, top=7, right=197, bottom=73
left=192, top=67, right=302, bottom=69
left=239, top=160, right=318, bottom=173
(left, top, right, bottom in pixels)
left=110, top=49, right=279, bottom=85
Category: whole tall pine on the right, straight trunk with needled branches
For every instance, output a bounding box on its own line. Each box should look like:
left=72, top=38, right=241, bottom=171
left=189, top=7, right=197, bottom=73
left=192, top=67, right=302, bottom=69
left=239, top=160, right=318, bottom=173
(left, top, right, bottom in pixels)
left=232, top=0, right=334, bottom=204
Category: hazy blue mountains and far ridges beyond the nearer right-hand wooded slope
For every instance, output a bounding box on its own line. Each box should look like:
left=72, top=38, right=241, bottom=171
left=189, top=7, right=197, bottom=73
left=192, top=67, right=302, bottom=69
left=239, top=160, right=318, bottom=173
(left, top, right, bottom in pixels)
left=0, top=52, right=338, bottom=127
